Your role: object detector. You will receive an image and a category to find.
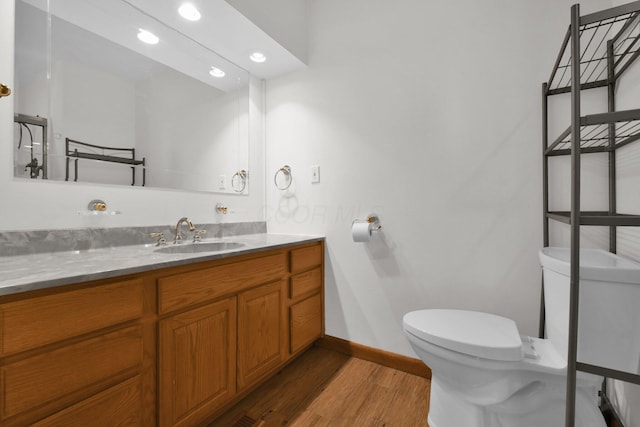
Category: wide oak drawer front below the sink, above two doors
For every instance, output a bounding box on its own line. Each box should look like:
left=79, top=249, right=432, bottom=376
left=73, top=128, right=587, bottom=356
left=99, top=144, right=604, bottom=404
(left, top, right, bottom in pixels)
left=158, top=252, right=287, bottom=314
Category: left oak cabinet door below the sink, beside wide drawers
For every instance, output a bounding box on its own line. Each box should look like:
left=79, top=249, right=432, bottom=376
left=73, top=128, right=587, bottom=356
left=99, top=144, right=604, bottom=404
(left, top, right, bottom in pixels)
left=158, top=297, right=236, bottom=426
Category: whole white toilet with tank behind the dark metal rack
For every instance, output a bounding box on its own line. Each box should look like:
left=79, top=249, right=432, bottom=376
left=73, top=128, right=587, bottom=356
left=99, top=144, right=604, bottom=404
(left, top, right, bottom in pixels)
left=403, top=247, right=640, bottom=427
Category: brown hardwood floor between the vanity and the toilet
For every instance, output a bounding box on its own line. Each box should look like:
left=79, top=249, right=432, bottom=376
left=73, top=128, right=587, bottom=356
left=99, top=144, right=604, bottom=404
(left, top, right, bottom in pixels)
left=209, top=347, right=430, bottom=427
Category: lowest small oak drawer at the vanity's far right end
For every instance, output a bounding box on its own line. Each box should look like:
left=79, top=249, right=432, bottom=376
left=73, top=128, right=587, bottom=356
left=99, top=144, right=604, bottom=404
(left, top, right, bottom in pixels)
left=290, top=294, right=322, bottom=353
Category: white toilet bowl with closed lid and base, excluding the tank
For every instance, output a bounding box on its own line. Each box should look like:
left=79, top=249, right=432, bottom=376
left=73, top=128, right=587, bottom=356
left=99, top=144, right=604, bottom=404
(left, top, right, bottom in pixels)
left=403, top=309, right=606, bottom=427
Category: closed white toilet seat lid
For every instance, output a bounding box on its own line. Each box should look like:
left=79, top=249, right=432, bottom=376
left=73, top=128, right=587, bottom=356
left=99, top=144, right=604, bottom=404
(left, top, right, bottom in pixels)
left=403, top=309, right=523, bottom=362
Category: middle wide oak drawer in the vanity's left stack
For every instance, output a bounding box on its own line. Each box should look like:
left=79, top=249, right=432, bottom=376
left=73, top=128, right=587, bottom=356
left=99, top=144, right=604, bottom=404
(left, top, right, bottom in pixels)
left=2, top=326, right=142, bottom=418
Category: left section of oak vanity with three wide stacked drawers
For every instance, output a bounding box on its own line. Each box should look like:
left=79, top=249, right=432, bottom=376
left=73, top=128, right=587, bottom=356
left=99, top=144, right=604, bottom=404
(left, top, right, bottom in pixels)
left=0, top=278, right=154, bottom=426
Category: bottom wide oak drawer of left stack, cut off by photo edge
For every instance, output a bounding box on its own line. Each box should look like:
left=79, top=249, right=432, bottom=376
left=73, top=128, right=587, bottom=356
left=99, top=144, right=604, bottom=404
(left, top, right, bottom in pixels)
left=33, top=376, right=142, bottom=427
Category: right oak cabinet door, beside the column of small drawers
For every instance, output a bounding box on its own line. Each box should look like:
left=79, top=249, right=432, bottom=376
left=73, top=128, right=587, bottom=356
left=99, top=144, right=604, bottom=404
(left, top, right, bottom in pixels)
left=238, top=281, right=286, bottom=389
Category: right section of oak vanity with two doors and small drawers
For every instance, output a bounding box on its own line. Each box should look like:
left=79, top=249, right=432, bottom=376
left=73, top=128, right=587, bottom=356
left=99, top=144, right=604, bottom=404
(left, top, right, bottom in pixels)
left=158, top=242, right=324, bottom=427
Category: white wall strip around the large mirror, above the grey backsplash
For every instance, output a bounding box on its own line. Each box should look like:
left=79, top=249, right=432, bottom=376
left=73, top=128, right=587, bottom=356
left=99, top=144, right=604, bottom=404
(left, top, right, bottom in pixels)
left=0, top=0, right=264, bottom=231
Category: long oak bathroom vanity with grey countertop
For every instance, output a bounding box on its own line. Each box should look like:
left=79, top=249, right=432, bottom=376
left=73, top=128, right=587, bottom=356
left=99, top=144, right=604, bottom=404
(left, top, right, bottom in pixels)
left=0, top=238, right=324, bottom=426
